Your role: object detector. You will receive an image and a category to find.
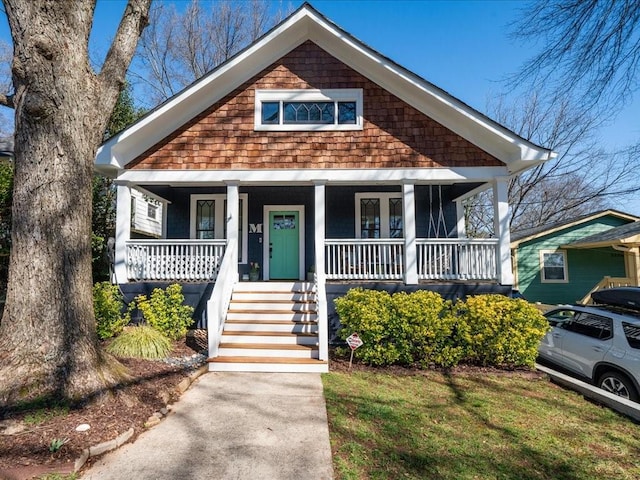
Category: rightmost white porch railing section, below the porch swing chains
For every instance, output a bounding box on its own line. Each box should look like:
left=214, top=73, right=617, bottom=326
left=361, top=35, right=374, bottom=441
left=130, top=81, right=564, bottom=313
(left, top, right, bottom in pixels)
left=416, top=238, right=498, bottom=280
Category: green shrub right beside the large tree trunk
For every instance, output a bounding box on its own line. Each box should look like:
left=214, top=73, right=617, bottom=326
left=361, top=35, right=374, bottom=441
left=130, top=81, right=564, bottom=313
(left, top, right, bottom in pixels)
left=93, top=282, right=131, bottom=340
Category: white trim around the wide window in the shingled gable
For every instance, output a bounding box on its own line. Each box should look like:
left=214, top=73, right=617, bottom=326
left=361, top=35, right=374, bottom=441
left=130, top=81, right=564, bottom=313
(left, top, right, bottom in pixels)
left=254, top=88, right=363, bottom=132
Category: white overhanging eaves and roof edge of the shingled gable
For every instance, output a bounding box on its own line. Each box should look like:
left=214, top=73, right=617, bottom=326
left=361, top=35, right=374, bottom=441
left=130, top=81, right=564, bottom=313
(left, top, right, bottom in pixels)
left=96, top=3, right=556, bottom=173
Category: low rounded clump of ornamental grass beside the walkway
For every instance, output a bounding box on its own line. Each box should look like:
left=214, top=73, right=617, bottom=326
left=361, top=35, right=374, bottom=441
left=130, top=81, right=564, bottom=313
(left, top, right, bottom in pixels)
left=107, top=325, right=171, bottom=359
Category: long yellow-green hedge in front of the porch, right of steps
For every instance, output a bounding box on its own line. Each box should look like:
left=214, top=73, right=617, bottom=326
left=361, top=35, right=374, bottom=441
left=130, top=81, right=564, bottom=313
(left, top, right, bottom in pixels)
left=335, top=288, right=548, bottom=367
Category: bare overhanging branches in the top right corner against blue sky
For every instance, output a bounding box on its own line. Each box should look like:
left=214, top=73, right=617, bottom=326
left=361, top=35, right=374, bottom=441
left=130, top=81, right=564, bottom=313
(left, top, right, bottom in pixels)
left=510, top=0, right=640, bottom=125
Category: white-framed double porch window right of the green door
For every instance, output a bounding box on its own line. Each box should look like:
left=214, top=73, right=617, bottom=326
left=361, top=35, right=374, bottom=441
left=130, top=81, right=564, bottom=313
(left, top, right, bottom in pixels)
left=356, top=192, right=404, bottom=238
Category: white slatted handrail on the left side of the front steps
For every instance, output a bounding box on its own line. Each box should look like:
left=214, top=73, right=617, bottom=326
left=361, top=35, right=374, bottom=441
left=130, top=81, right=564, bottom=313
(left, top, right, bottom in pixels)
left=207, top=239, right=238, bottom=358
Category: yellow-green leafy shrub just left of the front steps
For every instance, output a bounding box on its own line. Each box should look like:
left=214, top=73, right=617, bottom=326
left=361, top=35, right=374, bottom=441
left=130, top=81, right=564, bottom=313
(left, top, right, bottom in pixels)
left=136, top=283, right=193, bottom=340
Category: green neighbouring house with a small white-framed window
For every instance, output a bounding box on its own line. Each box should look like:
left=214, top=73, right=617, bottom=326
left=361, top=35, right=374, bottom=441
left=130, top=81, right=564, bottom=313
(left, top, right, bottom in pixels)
left=511, top=210, right=640, bottom=304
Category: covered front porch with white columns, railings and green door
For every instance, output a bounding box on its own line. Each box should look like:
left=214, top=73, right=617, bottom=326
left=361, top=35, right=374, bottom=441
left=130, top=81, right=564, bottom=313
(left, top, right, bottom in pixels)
left=115, top=181, right=512, bottom=285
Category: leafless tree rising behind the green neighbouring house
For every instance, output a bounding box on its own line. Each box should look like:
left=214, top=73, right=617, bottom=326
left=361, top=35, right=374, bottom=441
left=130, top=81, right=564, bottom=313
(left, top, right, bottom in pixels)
left=465, top=92, right=640, bottom=237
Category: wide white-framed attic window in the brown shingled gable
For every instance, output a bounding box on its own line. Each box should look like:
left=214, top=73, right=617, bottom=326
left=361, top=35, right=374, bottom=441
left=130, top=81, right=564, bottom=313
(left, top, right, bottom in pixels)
left=255, top=88, right=362, bottom=131
